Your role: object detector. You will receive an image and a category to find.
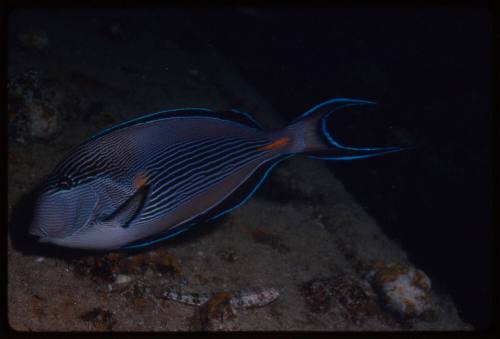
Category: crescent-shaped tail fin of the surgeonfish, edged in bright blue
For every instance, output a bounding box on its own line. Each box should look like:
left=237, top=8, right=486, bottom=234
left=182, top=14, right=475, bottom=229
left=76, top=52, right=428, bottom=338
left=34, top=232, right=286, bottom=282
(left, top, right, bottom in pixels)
left=287, top=98, right=408, bottom=160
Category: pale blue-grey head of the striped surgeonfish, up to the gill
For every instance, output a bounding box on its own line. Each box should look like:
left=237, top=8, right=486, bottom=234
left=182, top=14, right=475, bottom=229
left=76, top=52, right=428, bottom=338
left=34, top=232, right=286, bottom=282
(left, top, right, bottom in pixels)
left=29, top=173, right=141, bottom=250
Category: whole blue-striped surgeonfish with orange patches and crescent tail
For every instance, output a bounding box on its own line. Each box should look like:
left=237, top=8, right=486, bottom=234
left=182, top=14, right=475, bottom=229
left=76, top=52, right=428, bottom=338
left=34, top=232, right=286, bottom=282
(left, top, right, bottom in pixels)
left=30, top=99, right=403, bottom=250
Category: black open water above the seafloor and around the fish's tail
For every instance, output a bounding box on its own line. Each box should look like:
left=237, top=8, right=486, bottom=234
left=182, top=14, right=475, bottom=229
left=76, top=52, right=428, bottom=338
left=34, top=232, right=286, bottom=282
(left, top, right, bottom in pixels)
left=9, top=8, right=494, bottom=328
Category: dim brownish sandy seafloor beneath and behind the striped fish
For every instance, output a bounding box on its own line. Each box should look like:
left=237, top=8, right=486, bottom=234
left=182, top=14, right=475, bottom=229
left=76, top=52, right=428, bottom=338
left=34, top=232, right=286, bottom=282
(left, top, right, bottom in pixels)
left=8, top=11, right=472, bottom=331
